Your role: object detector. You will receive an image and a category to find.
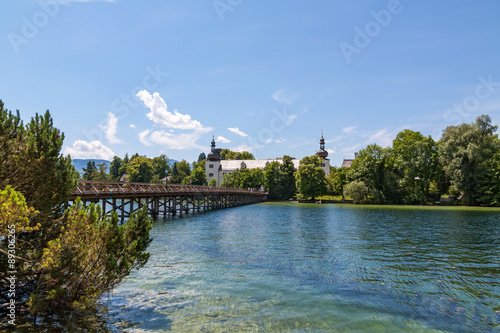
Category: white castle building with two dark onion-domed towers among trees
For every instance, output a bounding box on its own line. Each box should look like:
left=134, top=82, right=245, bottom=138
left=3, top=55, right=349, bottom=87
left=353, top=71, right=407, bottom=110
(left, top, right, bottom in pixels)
left=205, top=134, right=330, bottom=186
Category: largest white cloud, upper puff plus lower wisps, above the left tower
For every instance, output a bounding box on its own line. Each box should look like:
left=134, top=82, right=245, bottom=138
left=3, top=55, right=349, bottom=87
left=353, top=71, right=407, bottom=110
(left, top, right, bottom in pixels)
left=137, top=90, right=212, bottom=150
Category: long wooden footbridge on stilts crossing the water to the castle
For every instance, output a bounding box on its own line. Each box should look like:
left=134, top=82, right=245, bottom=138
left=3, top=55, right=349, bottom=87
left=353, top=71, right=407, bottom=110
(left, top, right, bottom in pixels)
left=70, top=181, right=267, bottom=221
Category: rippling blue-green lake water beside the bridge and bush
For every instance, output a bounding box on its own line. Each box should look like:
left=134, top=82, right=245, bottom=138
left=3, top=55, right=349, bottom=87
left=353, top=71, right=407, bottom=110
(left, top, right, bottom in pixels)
left=110, top=204, right=500, bottom=332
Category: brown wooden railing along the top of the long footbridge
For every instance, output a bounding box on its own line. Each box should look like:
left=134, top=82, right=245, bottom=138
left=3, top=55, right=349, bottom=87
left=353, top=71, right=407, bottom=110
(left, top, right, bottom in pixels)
left=72, top=180, right=264, bottom=196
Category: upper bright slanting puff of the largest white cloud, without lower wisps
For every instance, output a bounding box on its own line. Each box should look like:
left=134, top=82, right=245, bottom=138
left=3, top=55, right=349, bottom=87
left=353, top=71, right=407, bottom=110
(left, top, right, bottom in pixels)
left=137, top=90, right=204, bottom=130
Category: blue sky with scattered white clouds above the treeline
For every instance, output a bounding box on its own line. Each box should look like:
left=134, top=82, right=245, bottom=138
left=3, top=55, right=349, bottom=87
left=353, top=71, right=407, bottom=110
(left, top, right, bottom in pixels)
left=0, top=0, right=500, bottom=165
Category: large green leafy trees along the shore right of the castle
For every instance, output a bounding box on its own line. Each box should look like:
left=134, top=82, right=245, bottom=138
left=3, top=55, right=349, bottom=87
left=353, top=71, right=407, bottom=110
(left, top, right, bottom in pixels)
left=340, top=115, right=500, bottom=206
